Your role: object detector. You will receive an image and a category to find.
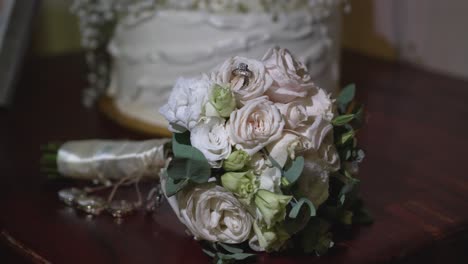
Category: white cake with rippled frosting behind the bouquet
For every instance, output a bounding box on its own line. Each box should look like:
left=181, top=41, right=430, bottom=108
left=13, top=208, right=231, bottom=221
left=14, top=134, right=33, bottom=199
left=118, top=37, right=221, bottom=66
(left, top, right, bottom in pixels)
left=107, top=0, right=341, bottom=131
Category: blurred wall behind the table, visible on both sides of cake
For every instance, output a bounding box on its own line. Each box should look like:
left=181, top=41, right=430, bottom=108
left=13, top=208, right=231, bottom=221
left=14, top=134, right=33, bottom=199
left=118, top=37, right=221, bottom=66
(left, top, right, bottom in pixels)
left=33, top=0, right=468, bottom=79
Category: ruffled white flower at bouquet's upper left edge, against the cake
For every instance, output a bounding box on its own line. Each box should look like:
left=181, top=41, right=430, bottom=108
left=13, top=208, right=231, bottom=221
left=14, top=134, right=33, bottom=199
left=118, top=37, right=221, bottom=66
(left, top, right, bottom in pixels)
left=159, top=76, right=212, bottom=133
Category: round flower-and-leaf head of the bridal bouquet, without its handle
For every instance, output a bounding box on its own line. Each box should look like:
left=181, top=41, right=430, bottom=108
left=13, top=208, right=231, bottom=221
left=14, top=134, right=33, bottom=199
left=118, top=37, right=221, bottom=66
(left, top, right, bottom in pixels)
left=160, top=48, right=369, bottom=261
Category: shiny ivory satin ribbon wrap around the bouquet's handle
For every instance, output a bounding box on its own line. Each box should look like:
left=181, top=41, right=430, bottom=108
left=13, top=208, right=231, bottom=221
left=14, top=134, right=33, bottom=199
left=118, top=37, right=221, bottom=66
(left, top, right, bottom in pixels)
left=57, top=139, right=170, bottom=180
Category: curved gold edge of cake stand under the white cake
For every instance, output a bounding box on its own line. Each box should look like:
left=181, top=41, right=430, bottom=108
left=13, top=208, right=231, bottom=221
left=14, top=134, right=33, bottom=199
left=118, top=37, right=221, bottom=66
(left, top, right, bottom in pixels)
left=98, top=96, right=172, bottom=137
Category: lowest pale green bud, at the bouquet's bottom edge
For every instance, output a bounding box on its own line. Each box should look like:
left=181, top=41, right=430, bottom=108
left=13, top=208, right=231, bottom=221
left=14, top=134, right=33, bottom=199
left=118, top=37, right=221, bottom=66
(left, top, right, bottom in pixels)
left=253, top=222, right=290, bottom=252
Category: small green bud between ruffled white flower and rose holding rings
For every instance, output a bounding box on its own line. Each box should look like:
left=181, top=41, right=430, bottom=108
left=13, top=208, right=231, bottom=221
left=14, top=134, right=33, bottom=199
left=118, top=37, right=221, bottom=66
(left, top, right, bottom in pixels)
left=210, top=84, right=236, bottom=117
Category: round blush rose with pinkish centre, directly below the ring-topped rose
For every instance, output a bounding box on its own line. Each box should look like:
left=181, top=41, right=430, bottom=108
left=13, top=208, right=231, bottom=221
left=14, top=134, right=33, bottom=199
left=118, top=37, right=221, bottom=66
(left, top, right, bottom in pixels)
left=228, top=97, right=284, bottom=156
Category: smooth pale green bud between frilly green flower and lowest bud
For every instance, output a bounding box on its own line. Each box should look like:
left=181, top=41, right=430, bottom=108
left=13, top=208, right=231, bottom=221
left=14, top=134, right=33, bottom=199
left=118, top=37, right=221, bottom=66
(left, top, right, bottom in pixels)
left=255, top=190, right=292, bottom=228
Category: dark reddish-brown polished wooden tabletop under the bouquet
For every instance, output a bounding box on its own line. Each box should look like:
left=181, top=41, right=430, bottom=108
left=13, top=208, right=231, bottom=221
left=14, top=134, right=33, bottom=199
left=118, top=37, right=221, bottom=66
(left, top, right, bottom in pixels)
left=0, top=52, right=468, bottom=264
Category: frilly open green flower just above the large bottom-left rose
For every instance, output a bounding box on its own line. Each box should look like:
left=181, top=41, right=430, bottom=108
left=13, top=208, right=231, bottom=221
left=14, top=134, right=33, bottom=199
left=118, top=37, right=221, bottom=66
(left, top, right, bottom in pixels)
left=221, top=171, right=258, bottom=204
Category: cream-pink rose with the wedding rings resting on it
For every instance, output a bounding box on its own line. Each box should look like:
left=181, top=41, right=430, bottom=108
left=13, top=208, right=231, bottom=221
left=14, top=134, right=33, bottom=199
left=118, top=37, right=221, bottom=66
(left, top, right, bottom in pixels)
left=211, top=57, right=273, bottom=105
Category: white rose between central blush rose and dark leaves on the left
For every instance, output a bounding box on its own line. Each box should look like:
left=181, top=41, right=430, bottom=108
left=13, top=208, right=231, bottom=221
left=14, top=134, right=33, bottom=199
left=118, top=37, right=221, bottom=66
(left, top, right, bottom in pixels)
left=190, top=117, right=231, bottom=168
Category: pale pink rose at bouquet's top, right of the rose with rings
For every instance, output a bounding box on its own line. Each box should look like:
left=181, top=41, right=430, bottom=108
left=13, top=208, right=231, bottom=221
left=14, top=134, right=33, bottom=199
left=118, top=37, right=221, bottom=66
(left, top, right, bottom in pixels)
left=263, top=48, right=315, bottom=103
